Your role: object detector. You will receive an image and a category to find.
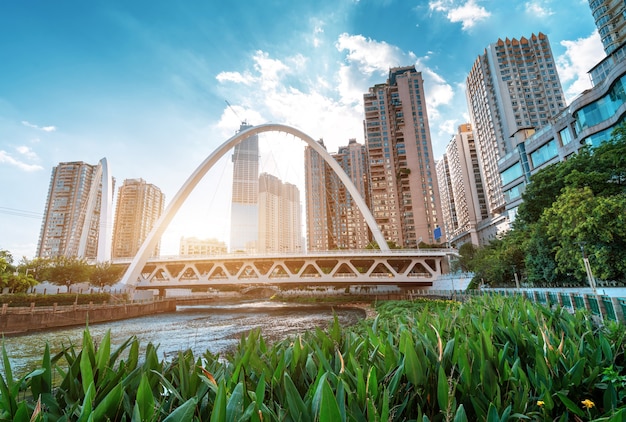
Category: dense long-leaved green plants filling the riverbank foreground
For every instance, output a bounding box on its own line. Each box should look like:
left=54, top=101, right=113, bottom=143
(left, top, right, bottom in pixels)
left=0, top=297, right=626, bottom=421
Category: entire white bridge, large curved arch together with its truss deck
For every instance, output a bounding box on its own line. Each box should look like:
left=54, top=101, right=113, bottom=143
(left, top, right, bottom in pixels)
left=122, top=123, right=453, bottom=289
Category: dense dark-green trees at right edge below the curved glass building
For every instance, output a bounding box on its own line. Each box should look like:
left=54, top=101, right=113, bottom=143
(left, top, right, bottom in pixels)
left=457, top=124, right=626, bottom=286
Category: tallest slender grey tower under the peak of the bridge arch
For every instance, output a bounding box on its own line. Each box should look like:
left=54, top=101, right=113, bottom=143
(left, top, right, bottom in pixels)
left=230, top=122, right=259, bottom=252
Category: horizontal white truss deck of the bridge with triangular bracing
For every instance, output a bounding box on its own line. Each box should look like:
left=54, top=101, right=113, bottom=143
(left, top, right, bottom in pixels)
left=117, top=249, right=456, bottom=290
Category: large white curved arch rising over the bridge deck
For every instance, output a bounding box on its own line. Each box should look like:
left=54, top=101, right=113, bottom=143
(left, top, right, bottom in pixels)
left=121, top=123, right=389, bottom=286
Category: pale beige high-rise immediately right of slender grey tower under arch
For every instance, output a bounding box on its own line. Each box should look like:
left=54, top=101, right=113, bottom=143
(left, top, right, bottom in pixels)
left=257, top=173, right=302, bottom=253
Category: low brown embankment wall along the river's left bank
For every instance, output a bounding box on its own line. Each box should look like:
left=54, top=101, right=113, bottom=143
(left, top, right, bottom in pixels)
left=0, top=300, right=176, bottom=335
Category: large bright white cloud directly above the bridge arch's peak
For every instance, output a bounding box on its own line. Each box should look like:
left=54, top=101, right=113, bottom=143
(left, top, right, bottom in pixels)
left=217, top=33, right=456, bottom=152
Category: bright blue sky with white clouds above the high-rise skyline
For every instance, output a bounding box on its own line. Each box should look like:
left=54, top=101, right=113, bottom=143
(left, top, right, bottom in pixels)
left=0, top=0, right=604, bottom=261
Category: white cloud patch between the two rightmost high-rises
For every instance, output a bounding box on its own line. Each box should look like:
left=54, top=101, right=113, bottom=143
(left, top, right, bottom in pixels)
left=556, top=31, right=605, bottom=103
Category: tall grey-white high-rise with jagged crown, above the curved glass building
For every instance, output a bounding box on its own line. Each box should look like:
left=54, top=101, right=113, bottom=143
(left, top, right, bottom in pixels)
left=466, top=33, right=565, bottom=231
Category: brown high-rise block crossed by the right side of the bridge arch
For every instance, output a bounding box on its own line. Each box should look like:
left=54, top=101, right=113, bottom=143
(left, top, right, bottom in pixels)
left=305, top=139, right=371, bottom=250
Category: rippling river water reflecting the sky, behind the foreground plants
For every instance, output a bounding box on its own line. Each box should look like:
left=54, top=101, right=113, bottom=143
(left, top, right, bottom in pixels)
left=0, top=301, right=364, bottom=377
